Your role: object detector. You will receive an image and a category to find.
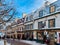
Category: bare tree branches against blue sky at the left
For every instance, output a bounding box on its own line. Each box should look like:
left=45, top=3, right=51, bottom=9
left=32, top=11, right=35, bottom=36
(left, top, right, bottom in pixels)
left=0, top=0, right=15, bottom=23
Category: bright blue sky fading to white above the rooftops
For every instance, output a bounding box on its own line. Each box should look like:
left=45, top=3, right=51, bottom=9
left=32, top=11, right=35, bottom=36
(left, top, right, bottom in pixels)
left=3, top=0, right=56, bottom=18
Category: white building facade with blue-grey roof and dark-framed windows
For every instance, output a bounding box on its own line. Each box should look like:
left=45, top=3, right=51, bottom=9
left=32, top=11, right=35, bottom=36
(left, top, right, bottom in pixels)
left=24, top=0, right=60, bottom=45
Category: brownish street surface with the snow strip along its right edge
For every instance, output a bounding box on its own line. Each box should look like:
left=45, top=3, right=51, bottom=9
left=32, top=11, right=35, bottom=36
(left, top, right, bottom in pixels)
left=7, top=39, right=46, bottom=45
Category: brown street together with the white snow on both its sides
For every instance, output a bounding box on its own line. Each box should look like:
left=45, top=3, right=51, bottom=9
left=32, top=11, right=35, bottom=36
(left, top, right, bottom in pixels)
left=0, top=39, right=46, bottom=45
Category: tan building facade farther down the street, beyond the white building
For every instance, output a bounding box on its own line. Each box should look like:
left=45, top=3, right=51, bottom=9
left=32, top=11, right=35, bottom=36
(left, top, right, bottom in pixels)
left=6, top=18, right=25, bottom=39
